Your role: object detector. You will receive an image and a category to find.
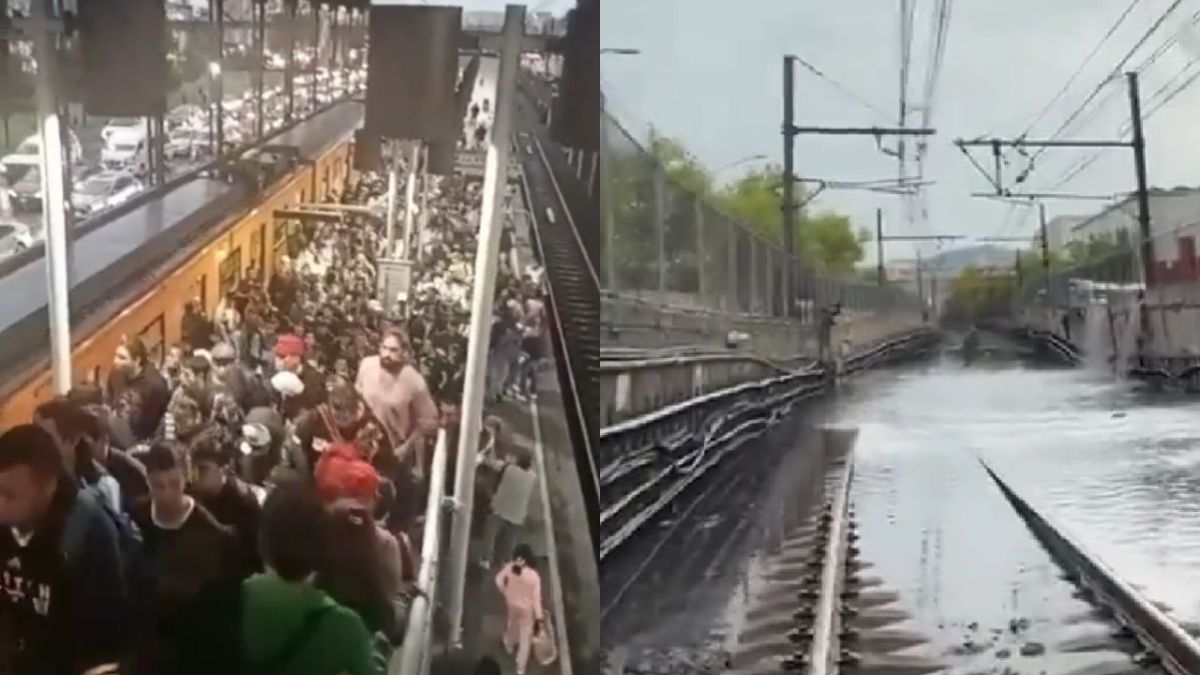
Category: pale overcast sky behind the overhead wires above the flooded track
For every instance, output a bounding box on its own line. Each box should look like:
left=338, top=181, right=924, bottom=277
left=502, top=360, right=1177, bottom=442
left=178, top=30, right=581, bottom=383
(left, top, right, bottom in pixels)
left=601, top=0, right=1200, bottom=257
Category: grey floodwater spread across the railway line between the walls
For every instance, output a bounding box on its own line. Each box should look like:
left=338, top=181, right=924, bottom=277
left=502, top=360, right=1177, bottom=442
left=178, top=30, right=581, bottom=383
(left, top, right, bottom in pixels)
left=601, top=343, right=1200, bottom=675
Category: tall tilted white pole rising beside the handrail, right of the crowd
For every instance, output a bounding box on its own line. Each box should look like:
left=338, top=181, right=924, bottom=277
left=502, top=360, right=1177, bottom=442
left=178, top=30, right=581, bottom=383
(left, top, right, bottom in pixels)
left=446, top=5, right=524, bottom=646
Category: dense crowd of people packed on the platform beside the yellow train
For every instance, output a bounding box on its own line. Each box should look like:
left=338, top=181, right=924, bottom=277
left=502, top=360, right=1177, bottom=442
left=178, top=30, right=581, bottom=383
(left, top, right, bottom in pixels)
left=0, top=132, right=546, bottom=675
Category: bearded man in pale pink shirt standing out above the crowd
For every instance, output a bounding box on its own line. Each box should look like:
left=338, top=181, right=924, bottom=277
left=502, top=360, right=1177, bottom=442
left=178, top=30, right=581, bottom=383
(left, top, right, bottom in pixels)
left=354, top=328, right=438, bottom=478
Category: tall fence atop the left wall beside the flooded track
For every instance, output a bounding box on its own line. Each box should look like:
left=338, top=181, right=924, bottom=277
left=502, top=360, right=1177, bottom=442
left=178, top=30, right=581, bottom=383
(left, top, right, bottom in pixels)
left=598, top=113, right=919, bottom=322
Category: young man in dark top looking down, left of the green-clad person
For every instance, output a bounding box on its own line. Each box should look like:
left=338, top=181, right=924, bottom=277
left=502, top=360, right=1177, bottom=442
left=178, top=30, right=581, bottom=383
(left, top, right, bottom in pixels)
left=132, top=441, right=241, bottom=675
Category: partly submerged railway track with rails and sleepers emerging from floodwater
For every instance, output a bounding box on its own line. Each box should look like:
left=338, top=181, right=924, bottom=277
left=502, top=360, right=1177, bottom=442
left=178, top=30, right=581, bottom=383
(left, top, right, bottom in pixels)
left=727, top=455, right=1200, bottom=675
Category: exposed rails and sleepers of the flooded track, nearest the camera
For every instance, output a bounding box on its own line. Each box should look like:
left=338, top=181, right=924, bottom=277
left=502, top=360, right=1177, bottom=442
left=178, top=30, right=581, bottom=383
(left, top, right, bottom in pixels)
left=727, top=443, right=1200, bottom=675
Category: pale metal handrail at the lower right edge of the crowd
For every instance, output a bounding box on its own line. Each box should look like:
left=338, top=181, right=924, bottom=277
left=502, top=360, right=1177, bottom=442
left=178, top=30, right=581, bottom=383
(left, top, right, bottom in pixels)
left=388, top=429, right=448, bottom=675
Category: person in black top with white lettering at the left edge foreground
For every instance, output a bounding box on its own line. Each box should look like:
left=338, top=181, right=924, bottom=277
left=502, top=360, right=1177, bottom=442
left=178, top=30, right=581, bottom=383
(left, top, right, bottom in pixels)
left=0, top=424, right=131, bottom=675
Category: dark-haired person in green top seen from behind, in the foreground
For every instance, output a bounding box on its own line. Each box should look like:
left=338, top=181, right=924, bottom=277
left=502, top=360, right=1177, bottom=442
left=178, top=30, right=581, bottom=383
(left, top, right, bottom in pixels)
left=241, top=484, right=380, bottom=675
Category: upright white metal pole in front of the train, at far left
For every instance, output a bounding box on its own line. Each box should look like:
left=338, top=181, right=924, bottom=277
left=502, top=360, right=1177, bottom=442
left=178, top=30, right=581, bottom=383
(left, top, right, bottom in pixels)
left=31, top=0, right=71, bottom=395
